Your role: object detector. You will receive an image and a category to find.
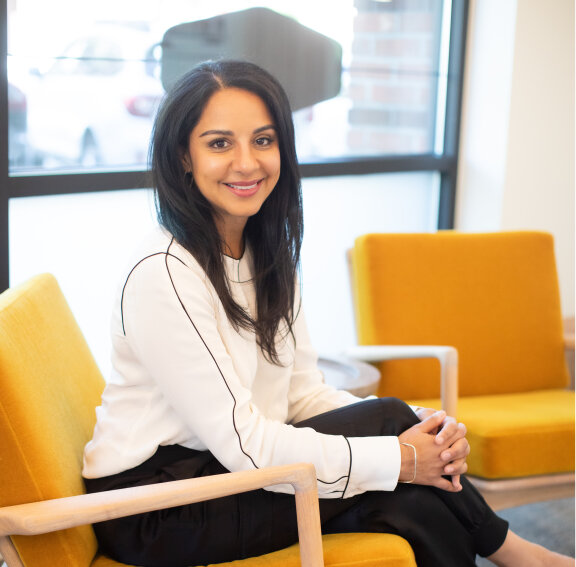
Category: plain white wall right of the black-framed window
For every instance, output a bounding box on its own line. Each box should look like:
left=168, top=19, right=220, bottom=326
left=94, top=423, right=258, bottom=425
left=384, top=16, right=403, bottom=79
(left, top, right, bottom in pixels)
left=456, top=0, right=575, bottom=316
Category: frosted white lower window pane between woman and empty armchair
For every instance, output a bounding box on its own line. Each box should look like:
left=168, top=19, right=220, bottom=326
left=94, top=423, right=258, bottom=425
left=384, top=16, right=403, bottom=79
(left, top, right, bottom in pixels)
left=302, top=172, right=438, bottom=355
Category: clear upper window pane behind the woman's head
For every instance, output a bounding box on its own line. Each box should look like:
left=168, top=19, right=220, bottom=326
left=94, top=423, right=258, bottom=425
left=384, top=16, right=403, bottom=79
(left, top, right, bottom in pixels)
left=8, top=0, right=450, bottom=173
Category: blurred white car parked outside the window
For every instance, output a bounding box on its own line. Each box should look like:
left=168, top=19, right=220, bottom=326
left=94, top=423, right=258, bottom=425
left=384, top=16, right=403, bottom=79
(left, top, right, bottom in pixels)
left=26, top=25, right=164, bottom=167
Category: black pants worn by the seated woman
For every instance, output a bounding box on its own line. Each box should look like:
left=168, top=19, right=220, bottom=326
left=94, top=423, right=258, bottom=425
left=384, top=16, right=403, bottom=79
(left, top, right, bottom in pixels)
left=85, top=398, right=508, bottom=567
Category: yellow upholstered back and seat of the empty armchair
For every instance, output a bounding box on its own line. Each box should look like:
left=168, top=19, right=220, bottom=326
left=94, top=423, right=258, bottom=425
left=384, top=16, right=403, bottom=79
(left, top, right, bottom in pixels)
left=352, top=231, right=574, bottom=507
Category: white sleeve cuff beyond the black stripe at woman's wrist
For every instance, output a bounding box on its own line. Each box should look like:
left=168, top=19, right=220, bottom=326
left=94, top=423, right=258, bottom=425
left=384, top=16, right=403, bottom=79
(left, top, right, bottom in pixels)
left=344, top=436, right=401, bottom=498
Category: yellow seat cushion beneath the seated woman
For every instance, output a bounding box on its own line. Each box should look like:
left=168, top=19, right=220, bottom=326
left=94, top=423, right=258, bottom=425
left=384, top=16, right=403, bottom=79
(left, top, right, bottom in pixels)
left=92, top=534, right=416, bottom=567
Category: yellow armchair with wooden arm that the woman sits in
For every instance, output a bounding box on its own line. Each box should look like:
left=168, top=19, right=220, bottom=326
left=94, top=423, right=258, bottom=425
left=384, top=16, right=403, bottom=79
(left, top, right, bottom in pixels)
left=0, top=274, right=416, bottom=567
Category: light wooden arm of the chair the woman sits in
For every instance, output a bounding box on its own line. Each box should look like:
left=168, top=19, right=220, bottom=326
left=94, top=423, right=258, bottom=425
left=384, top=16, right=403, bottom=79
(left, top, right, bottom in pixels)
left=0, top=463, right=324, bottom=567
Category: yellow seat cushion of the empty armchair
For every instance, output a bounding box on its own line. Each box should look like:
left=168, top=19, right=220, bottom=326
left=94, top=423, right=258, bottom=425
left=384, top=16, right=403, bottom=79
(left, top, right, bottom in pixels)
left=410, top=390, right=575, bottom=479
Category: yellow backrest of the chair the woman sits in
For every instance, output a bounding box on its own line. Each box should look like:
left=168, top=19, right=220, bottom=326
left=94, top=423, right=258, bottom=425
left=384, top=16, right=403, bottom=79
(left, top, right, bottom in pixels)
left=0, top=274, right=104, bottom=567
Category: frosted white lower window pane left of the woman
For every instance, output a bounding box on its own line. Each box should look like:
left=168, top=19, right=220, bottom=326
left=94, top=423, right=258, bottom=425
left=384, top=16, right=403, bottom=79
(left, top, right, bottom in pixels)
left=10, top=189, right=156, bottom=375
